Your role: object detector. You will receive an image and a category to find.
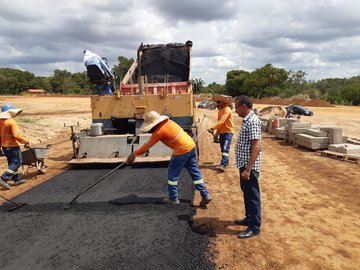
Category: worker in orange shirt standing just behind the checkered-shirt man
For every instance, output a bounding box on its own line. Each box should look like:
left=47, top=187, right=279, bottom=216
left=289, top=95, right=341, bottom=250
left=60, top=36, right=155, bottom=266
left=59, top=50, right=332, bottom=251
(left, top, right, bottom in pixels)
left=210, top=95, right=234, bottom=172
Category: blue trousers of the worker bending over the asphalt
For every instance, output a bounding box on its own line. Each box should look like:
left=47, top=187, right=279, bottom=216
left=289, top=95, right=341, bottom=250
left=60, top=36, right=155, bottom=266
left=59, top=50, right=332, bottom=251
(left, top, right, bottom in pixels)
left=168, top=147, right=209, bottom=200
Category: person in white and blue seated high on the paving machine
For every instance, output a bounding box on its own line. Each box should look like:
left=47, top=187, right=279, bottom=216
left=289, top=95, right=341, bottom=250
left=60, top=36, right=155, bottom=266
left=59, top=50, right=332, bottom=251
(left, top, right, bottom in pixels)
left=83, top=50, right=114, bottom=96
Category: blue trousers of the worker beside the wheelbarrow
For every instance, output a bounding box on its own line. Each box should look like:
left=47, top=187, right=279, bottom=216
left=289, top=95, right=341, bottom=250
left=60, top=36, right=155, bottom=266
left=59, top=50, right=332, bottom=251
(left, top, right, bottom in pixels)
left=1, top=146, right=22, bottom=182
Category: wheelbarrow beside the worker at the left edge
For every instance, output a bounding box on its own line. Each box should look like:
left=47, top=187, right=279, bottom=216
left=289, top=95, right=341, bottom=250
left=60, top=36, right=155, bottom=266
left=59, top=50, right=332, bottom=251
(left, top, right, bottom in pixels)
left=21, top=144, right=51, bottom=175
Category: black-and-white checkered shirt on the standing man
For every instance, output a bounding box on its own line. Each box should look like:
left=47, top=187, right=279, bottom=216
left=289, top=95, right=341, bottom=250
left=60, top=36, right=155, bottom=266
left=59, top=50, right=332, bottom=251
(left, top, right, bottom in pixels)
left=235, top=111, right=262, bottom=172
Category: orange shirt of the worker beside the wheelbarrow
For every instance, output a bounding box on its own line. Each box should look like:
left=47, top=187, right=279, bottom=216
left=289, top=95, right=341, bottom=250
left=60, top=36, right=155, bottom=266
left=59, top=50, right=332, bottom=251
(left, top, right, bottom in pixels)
left=0, top=118, right=29, bottom=147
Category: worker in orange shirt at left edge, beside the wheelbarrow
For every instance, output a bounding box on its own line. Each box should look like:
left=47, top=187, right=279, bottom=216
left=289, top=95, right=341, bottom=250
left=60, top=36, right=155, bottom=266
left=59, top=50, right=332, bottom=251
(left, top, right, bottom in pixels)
left=0, top=103, right=29, bottom=189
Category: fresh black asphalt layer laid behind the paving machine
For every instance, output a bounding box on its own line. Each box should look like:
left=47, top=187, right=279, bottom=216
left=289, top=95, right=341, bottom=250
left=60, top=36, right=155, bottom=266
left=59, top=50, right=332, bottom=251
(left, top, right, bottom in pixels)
left=0, top=167, right=214, bottom=270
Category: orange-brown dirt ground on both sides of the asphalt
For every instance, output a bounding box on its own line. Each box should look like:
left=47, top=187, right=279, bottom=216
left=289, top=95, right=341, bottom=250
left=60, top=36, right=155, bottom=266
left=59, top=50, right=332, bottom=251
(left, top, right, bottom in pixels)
left=0, top=97, right=360, bottom=269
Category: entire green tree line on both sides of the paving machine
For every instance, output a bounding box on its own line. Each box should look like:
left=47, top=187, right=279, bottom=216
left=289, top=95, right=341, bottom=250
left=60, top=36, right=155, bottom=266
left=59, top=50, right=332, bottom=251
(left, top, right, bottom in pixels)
left=0, top=59, right=360, bottom=105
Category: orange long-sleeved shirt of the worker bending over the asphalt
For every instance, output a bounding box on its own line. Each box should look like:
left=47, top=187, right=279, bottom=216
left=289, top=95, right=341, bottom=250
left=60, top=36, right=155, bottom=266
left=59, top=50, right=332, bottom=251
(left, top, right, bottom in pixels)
left=133, top=119, right=195, bottom=156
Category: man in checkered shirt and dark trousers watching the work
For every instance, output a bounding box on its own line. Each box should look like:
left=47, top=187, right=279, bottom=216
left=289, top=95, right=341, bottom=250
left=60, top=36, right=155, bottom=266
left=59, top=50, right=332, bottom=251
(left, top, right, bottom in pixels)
left=235, top=96, right=262, bottom=239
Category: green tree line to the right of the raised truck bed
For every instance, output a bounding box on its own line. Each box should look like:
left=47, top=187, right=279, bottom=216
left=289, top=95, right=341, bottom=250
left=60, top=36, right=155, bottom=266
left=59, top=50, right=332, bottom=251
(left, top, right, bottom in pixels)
left=192, top=64, right=360, bottom=105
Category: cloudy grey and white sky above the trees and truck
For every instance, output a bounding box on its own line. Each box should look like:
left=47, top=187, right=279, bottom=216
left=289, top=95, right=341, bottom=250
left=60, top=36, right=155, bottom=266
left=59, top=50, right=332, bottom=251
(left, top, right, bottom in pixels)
left=0, top=0, right=360, bottom=84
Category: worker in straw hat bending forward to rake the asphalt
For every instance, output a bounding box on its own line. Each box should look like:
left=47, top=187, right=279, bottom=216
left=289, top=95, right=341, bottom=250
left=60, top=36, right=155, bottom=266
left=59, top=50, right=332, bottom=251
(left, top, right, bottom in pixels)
left=126, top=111, right=211, bottom=206
